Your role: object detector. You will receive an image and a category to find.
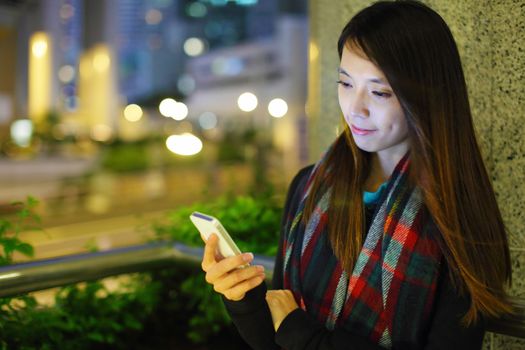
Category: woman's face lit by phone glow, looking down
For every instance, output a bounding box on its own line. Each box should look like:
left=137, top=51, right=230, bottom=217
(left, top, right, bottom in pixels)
left=338, top=46, right=408, bottom=159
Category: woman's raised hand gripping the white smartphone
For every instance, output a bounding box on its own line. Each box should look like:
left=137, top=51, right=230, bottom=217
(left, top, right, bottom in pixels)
left=202, top=234, right=265, bottom=301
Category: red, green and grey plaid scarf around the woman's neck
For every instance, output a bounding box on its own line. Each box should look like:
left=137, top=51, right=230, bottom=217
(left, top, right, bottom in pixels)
left=283, top=150, right=442, bottom=349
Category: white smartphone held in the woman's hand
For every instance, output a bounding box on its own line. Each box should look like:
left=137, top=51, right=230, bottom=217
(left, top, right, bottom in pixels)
left=190, top=211, right=241, bottom=258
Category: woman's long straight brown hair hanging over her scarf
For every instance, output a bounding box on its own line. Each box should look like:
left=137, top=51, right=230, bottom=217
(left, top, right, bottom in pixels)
left=303, top=0, right=512, bottom=324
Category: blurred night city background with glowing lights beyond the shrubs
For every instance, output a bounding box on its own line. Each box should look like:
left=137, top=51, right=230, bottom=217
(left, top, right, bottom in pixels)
left=0, top=0, right=308, bottom=259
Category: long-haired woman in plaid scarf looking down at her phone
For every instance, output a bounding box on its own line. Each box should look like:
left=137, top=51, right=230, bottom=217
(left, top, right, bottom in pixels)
left=202, top=1, right=511, bottom=349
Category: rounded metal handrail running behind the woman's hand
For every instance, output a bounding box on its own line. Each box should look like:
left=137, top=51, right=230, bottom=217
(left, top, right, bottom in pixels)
left=0, top=242, right=525, bottom=338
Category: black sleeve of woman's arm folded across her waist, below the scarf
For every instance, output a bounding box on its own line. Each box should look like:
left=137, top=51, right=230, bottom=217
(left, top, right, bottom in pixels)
left=275, top=274, right=485, bottom=350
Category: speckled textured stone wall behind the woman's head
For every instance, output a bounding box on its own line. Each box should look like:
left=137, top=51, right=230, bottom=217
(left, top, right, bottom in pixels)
left=307, top=0, right=525, bottom=350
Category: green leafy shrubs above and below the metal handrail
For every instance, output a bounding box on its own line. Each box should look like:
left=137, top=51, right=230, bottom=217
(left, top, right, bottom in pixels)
left=0, top=196, right=281, bottom=350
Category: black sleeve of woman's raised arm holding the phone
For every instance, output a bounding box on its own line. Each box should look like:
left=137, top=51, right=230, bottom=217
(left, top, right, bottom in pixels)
left=223, top=166, right=312, bottom=350
